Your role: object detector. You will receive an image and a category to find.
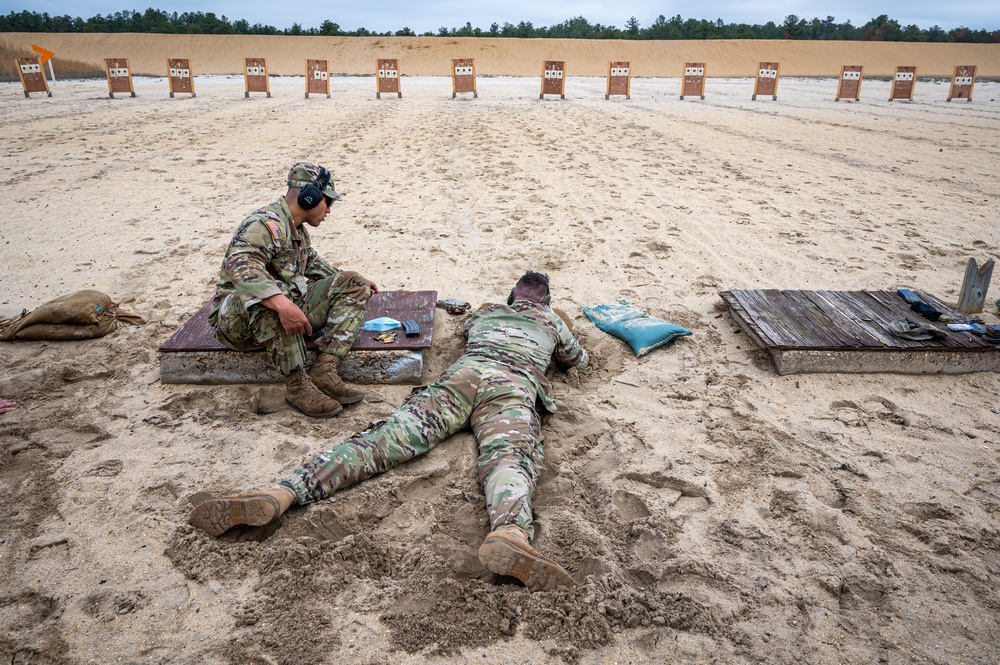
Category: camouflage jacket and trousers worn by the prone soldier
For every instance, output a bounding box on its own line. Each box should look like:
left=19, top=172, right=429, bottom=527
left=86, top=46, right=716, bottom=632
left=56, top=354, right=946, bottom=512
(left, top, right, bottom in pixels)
left=281, top=300, right=589, bottom=538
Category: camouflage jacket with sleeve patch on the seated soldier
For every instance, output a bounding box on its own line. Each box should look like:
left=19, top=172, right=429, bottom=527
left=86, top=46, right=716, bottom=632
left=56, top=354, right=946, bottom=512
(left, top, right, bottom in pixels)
left=208, top=197, right=340, bottom=326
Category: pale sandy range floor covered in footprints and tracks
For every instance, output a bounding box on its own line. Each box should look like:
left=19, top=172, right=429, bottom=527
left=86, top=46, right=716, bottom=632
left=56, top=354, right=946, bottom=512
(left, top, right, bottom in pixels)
left=0, top=68, right=1000, bottom=664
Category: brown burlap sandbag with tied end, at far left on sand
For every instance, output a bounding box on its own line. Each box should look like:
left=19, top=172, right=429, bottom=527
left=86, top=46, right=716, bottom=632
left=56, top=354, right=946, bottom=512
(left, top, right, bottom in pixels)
left=0, top=290, right=145, bottom=342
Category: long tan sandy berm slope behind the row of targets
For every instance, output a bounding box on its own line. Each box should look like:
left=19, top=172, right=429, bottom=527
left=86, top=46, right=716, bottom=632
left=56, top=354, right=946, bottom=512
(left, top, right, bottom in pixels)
left=3, top=32, right=1000, bottom=78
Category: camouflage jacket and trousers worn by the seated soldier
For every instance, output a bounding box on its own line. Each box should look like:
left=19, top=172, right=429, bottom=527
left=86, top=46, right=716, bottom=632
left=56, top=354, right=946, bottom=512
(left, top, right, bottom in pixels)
left=208, top=198, right=371, bottom=375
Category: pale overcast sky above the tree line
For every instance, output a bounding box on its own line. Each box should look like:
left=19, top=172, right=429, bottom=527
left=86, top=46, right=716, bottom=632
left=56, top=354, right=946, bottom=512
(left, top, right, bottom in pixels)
left=0, top=0, right=1000, bottom=34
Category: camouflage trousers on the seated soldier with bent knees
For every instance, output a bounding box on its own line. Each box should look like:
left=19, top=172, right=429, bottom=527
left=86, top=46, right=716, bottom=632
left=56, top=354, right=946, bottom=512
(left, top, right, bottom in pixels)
left=215, top=270, right=371, bottom=376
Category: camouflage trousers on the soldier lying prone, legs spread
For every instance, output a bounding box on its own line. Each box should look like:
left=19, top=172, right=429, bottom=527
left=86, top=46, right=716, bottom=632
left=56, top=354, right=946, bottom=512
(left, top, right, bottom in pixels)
left=281, top=356, right=542, bottom=538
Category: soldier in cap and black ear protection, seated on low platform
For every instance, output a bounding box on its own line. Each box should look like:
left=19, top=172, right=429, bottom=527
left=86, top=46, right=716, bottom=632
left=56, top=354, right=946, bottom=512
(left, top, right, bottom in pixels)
left=208, top=162, right=378, bottom=418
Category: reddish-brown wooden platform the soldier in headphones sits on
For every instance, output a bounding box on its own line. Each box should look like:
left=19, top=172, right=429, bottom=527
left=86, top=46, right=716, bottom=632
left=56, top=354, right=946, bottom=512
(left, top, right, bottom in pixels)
left=160, top=291, right=437, bottom=385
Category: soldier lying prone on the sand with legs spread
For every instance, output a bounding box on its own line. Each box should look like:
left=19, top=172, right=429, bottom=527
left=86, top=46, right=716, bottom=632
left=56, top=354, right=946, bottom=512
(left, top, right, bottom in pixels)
left=189, top=272, right=590, bottom=591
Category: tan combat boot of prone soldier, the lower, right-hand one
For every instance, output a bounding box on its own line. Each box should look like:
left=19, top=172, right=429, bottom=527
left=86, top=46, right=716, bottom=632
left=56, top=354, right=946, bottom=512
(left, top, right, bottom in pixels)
left=479, top=524, right=576, bottom=592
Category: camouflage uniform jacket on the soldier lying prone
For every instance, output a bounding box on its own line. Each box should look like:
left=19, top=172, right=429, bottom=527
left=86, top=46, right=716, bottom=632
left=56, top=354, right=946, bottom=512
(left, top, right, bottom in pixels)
left=459, top=300, right=590, bottom=412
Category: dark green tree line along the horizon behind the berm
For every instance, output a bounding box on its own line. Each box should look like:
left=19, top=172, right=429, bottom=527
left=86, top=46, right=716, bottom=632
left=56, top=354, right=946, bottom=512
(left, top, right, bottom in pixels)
left=0, top=8, right=1000, bottom=44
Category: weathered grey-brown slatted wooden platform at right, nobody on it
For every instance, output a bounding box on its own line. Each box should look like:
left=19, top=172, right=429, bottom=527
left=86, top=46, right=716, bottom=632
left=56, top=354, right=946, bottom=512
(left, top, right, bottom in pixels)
left=719, top=289, right=1000, bottom=374
